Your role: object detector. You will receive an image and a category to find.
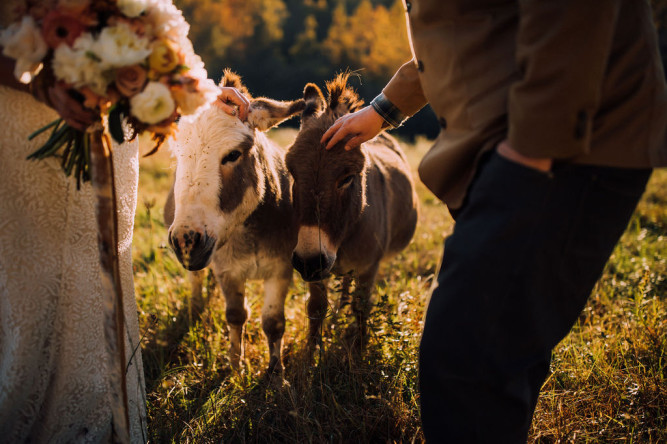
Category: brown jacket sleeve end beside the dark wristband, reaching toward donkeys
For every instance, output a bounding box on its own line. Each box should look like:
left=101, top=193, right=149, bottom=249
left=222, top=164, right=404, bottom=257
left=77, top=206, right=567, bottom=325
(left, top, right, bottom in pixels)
left=378, top=60, right=427, bottom=121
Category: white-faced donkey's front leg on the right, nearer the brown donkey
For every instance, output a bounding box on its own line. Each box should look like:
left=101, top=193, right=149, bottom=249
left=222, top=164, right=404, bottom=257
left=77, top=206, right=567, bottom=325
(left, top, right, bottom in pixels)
left=262, top=274, right=292, bottom=373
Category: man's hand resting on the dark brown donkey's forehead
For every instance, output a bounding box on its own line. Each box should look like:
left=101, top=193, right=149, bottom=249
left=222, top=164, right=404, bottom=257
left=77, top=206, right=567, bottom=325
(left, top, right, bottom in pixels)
left=320, top=106, right=385, bottom=150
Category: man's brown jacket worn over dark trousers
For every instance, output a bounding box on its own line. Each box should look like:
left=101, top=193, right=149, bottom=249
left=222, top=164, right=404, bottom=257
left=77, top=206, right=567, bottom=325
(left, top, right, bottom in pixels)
left=383, top=0, right=667, bottom=208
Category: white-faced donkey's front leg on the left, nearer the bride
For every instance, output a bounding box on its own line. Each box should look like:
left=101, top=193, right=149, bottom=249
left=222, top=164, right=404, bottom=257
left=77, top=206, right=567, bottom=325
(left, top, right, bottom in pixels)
left=217, top=275, right=248, bottom=369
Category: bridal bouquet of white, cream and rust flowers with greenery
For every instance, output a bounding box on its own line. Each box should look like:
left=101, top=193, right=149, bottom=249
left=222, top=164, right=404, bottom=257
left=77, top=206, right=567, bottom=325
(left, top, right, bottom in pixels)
left=0, top=0, right=219, bottom=185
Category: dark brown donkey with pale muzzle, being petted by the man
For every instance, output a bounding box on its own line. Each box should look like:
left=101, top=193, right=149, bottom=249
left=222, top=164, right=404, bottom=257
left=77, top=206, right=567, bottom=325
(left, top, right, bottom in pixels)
left=285, top=74, right=418, bottom=344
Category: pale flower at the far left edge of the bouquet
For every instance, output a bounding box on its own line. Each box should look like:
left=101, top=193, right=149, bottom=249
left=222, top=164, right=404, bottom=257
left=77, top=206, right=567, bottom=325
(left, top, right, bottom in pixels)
left=0, top=16, right=48, bottom=83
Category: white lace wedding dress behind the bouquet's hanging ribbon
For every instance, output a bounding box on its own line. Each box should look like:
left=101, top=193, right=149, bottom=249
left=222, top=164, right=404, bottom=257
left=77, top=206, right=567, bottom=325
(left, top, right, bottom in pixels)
left=0, top=86, right=146, bottom=443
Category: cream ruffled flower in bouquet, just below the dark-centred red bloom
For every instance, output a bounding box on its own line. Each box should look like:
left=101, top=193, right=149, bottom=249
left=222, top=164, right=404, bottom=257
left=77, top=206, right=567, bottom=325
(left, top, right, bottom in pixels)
left=53, top=33, right=112, bottom=96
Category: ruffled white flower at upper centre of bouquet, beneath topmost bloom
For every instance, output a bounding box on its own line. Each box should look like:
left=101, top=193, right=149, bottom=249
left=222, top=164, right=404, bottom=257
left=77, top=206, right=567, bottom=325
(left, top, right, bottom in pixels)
left=92, top=23, right=151, bottom=68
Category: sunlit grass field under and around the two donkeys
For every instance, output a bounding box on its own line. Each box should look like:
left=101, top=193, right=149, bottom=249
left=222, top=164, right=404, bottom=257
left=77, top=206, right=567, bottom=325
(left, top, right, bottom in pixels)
left=133, top=129, right=667, bottom=443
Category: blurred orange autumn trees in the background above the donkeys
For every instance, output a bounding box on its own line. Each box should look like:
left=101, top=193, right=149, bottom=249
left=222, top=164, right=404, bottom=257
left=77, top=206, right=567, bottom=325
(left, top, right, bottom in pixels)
left=175, top=0, right=438, bottom=136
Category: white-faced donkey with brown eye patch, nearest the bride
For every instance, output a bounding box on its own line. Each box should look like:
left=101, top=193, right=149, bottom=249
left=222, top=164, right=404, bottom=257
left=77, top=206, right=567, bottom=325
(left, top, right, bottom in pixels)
left=164, top=71, right=305, bottom=372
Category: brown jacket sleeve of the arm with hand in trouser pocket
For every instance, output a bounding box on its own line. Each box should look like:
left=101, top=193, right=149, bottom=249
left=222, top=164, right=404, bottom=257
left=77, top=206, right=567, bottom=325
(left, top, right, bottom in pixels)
left=508, top=0, right=620, bottom=159
